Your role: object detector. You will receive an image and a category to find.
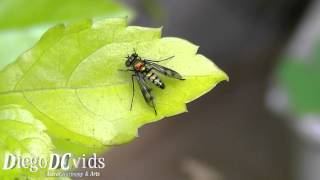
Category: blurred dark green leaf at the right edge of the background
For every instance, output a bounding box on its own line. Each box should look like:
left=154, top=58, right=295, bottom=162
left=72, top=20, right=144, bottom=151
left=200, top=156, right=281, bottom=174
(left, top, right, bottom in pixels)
left=278, top=44, right=320, bottom=114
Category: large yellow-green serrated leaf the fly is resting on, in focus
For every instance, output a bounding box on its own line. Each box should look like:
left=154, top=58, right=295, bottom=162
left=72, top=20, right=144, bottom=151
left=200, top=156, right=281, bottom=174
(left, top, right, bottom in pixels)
left=0, top=19, right=228, bottom=153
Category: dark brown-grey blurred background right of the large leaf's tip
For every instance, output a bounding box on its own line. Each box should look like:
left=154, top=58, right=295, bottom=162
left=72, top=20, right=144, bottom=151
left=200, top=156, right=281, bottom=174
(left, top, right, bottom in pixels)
left=83, top=0, right=311, bottom=180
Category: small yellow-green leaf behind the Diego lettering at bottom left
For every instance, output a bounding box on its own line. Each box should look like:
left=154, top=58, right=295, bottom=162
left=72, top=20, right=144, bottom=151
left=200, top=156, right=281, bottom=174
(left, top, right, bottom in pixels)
left=0, top=105, right=53, bottom=179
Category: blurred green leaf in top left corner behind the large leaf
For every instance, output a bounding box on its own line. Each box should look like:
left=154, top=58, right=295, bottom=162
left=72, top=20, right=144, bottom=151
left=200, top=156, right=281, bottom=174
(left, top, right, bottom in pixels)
left=0, top=0, right=133, bottom=69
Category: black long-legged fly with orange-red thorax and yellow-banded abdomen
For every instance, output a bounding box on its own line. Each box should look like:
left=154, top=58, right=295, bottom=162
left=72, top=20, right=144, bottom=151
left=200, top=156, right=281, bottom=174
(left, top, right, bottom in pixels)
left=121, top=50, right=185, bottom=115
